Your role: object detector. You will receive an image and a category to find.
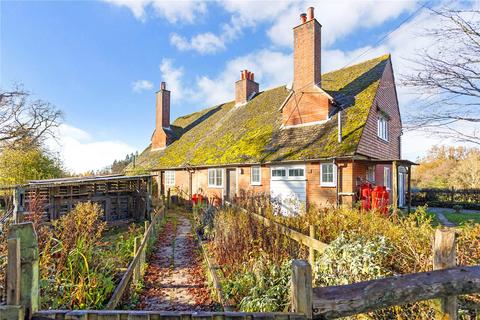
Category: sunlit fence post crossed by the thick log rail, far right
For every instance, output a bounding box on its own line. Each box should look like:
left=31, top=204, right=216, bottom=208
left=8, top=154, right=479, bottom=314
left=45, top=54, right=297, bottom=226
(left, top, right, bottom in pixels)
left=433, top=229, right=458, bottom=320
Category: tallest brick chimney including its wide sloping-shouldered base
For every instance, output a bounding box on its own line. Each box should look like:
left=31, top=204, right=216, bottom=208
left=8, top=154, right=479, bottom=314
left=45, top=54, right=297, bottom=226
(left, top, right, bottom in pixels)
left=281, top=7, right=333, bottom=128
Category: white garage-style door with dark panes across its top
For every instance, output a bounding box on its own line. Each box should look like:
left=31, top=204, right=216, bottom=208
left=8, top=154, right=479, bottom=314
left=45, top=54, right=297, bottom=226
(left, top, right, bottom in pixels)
left=270, top=165, right=307, bottom=215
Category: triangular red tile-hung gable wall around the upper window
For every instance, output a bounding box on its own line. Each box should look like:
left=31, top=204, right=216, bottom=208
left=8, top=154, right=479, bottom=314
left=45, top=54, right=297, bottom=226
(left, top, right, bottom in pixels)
left=357, top=60, right=402, bottom=159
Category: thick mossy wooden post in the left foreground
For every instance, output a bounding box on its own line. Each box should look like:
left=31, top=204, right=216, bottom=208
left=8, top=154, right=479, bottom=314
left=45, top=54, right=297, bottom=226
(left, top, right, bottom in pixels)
left=8, top=222, right=39, bottom=319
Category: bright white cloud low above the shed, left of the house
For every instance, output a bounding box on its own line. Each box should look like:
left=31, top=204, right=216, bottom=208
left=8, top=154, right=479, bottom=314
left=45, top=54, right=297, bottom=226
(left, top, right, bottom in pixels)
left=48, top=124, right=135, bottom=173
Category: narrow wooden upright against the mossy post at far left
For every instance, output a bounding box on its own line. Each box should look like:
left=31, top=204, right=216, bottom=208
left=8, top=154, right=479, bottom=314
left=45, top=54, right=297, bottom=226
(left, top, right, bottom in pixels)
left=7, top=238, right=21, bottom=305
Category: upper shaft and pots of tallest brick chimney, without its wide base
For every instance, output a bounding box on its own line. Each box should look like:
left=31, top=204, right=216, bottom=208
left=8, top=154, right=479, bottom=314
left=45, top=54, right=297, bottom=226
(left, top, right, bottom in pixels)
left=293, top=7, right=322, bottom=91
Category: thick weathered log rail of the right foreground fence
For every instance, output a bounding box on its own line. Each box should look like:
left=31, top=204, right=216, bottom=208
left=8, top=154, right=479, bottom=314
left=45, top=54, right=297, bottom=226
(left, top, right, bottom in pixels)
left=312, top=266, right=480, bottom=319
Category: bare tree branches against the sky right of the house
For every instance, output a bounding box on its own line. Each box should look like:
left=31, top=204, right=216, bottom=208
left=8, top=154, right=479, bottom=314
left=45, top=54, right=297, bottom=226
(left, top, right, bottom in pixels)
left=402, top=9, right=480, bottom=145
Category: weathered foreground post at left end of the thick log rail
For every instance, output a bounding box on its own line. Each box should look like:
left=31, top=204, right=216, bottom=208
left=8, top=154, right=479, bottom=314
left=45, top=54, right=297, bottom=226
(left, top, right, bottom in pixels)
left=291, top=260, right=313, bottom=319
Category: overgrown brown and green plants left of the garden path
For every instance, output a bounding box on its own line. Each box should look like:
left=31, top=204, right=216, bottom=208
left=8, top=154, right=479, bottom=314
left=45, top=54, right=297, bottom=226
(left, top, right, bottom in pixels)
left=34, top=203, right=142, bottom=309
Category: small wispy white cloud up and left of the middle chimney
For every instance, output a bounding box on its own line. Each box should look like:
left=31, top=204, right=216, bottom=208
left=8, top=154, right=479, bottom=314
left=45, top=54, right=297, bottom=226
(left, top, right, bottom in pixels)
left=170, top=32, right=225, bottom=54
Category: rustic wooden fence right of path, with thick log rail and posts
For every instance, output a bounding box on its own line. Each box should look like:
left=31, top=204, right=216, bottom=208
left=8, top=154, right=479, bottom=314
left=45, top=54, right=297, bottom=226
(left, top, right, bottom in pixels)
left=225, top=202, right=480, bottom=320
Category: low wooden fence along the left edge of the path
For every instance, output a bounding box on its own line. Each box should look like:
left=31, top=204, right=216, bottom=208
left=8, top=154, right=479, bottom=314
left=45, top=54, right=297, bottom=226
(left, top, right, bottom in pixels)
left=105, top=206, right=166, bottom=310
